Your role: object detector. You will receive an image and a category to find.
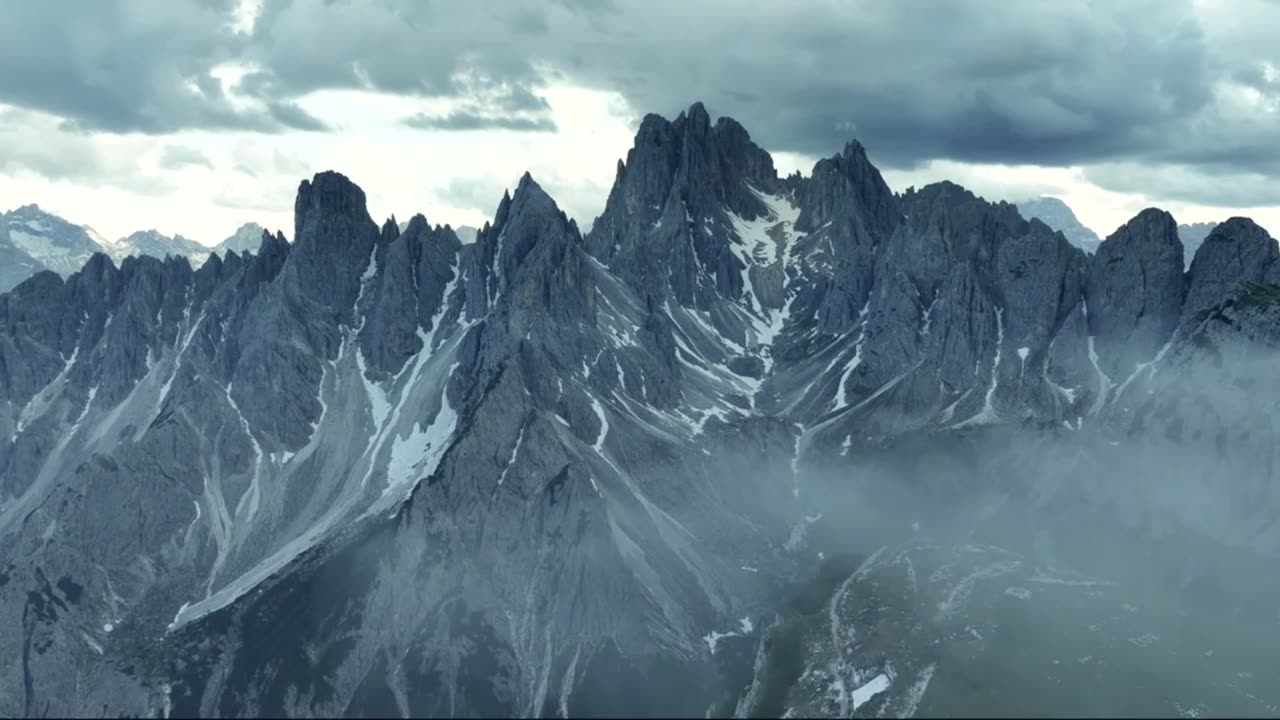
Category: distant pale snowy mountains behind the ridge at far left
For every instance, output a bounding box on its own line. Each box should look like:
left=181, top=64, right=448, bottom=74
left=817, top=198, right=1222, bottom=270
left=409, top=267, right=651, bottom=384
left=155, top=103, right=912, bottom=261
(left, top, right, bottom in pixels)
left=0, top=205, right=276, bottom=292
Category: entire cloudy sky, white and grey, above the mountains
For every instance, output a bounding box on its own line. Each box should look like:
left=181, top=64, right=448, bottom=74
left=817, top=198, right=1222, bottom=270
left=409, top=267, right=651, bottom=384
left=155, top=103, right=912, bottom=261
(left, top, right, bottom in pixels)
left=0, top=0, right=1280, bottom=243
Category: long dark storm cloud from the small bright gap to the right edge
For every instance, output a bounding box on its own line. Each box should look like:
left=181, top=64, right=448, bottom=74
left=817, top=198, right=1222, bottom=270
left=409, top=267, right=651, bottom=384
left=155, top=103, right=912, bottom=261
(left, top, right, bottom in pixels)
left=232, top=0, right=1280, bottom=173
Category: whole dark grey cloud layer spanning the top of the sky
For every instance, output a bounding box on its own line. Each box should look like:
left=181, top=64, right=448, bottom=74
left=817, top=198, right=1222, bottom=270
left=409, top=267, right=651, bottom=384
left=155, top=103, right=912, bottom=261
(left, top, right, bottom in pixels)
left=0, top=0, right=1280, bottom=202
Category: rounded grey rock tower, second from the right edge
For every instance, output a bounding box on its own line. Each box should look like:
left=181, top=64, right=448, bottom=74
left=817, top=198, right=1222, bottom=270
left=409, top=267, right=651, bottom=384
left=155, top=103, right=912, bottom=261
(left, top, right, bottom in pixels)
left=1084, top=209, right=1185, bottom=379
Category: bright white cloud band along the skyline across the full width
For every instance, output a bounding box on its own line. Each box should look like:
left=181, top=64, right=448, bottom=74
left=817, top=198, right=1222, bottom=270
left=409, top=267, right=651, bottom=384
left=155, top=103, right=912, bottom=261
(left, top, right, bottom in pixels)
left=0, top=78, right=1280, bottom=243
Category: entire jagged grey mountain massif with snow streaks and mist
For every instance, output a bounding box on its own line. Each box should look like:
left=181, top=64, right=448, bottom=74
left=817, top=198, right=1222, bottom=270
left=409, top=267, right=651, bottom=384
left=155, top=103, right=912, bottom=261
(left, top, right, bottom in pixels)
left=0, top=104, right=1280, bottom=717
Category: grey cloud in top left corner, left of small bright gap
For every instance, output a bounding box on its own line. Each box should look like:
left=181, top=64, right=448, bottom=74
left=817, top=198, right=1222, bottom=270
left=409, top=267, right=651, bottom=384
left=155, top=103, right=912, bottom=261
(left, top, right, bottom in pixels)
left=0, top=0, right=330, bottom=133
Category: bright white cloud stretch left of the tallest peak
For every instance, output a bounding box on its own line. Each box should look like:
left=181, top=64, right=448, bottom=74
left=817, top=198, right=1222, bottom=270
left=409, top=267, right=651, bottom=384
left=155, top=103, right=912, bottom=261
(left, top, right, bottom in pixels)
left=0, top=87, right=636, bottom=243
